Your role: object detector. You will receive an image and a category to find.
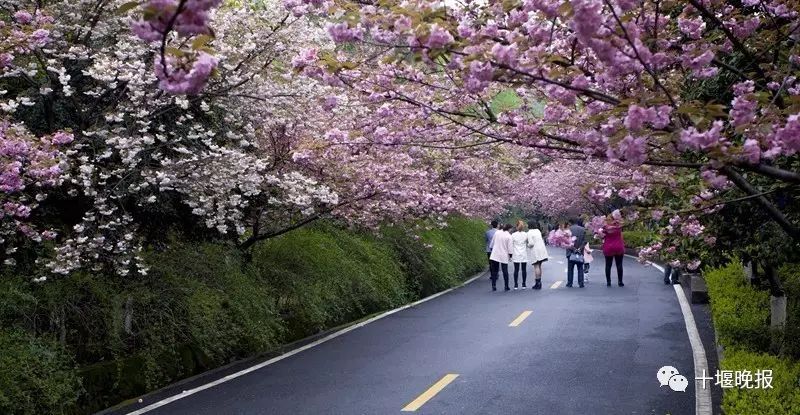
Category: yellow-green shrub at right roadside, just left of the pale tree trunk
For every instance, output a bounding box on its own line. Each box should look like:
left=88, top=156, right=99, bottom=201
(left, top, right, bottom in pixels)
left=705, top=261, right=770, bottom=351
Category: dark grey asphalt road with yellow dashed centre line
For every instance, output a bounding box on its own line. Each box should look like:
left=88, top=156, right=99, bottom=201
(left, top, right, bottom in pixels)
left=133, top=248, right=695, bottom=415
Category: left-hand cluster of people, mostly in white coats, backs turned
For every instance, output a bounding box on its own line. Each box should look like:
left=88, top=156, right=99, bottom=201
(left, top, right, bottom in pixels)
left=486, top=220, right=549, bottom=291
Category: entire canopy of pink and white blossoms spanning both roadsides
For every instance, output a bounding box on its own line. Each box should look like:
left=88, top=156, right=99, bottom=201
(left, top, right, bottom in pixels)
left=0, top=0, right=800, bottom=277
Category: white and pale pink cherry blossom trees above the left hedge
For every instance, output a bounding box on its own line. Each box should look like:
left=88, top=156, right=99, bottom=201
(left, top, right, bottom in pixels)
left=0, top=0, right=520, bottom=280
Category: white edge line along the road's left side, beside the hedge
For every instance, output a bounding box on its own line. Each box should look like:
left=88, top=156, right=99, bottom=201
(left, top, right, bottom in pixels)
left=127, top=271, right=486, bottom=415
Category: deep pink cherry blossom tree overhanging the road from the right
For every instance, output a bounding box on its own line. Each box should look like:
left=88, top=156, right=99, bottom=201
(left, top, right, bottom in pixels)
left=290, top=0, right=800, bottom=272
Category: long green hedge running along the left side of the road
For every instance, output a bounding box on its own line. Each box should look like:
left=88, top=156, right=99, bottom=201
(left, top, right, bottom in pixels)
left=0, top=218, right=486, bottom=414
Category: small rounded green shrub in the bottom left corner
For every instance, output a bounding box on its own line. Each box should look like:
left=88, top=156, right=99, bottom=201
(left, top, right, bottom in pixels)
left=0, top=329, right=80, bottom=415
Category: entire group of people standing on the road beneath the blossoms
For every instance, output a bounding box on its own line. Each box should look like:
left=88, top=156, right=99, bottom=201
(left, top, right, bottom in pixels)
left=486, top=218, right=625, bottom=291
